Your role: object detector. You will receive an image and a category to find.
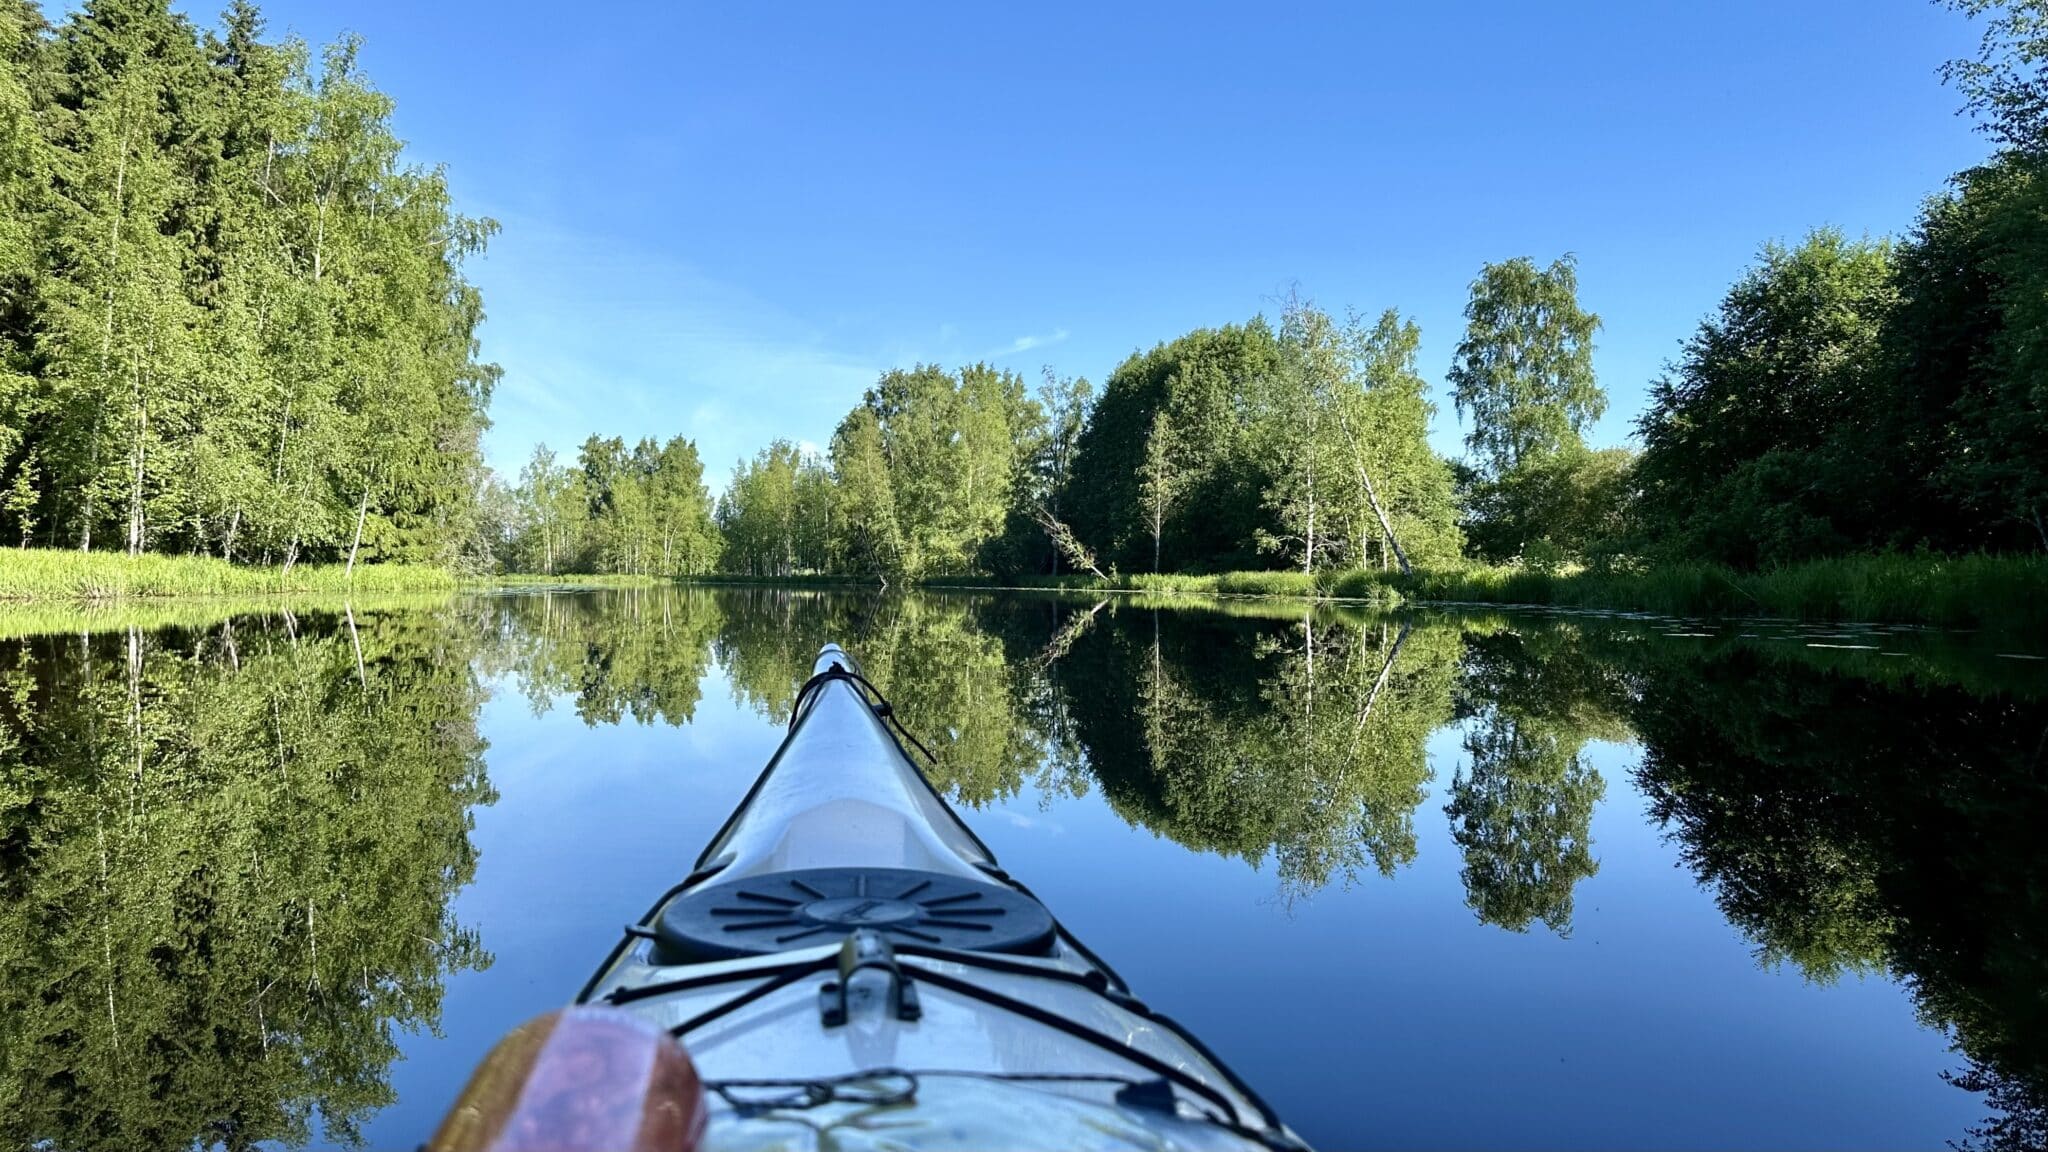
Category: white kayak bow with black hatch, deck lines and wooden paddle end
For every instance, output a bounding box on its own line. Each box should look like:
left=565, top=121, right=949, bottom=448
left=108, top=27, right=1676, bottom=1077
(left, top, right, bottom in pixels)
left=428, top=646, right=1307, bottom=1152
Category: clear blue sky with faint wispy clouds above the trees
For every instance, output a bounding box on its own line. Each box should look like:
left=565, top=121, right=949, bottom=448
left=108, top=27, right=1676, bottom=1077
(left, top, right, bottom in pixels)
left=220, top=0, right=1985, bottom=488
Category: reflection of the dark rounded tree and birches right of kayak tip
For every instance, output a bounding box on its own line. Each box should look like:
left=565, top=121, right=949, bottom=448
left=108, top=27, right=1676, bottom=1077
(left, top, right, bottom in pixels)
left=1053, top=609, right=1460, bottom=898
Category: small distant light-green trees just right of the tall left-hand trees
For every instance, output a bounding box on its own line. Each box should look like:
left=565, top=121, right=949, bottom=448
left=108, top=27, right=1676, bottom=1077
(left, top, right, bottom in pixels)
left=487, top=437, right=723, bottom=576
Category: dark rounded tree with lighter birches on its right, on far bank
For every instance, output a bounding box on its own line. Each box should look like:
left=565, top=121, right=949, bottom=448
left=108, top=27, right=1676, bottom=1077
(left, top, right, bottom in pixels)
left=1061, top=299, right=1460, bottom=572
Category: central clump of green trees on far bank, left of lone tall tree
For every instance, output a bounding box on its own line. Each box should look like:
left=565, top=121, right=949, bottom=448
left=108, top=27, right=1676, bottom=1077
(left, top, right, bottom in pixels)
left=671, top=299, right=1460, bottom=580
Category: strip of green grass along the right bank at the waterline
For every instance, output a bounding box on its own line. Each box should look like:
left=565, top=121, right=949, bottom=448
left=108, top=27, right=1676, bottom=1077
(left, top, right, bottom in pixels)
left=1401, top=556, right=2048, bottom=631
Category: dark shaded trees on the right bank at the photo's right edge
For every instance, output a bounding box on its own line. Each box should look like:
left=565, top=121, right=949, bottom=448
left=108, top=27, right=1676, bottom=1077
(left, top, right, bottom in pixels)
left=1632, top=0, right=2048, bottom=566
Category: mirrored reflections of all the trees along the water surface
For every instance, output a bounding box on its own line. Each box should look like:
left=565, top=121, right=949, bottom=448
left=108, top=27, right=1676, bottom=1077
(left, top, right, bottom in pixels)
left=0, top=588, right=2048, bottom=1148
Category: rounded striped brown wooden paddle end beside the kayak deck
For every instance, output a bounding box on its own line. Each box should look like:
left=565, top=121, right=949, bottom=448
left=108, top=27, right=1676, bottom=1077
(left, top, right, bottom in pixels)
left=426, top=1006, right=707, bottom=1152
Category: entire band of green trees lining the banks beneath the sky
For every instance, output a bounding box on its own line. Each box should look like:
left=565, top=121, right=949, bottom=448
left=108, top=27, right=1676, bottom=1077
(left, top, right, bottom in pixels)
left=0, top=0, right=2048, bottom=619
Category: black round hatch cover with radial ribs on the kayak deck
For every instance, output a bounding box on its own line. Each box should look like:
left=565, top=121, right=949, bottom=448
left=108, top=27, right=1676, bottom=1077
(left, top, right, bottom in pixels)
left=653, top=867, right=1053, bottom=963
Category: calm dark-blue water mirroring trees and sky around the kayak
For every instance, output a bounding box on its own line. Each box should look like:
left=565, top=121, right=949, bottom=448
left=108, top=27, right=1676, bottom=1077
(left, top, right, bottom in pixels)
left=0, top=590, right=2048, bottom=1150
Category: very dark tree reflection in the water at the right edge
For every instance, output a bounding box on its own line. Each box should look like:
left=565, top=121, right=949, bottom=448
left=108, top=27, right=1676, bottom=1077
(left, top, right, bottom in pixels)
left=1618, top=646, right=2048, bottom=1148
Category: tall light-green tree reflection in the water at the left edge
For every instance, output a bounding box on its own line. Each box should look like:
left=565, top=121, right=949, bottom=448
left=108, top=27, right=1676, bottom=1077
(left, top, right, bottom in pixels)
left=0, top=613, right=496, bottom=1150
